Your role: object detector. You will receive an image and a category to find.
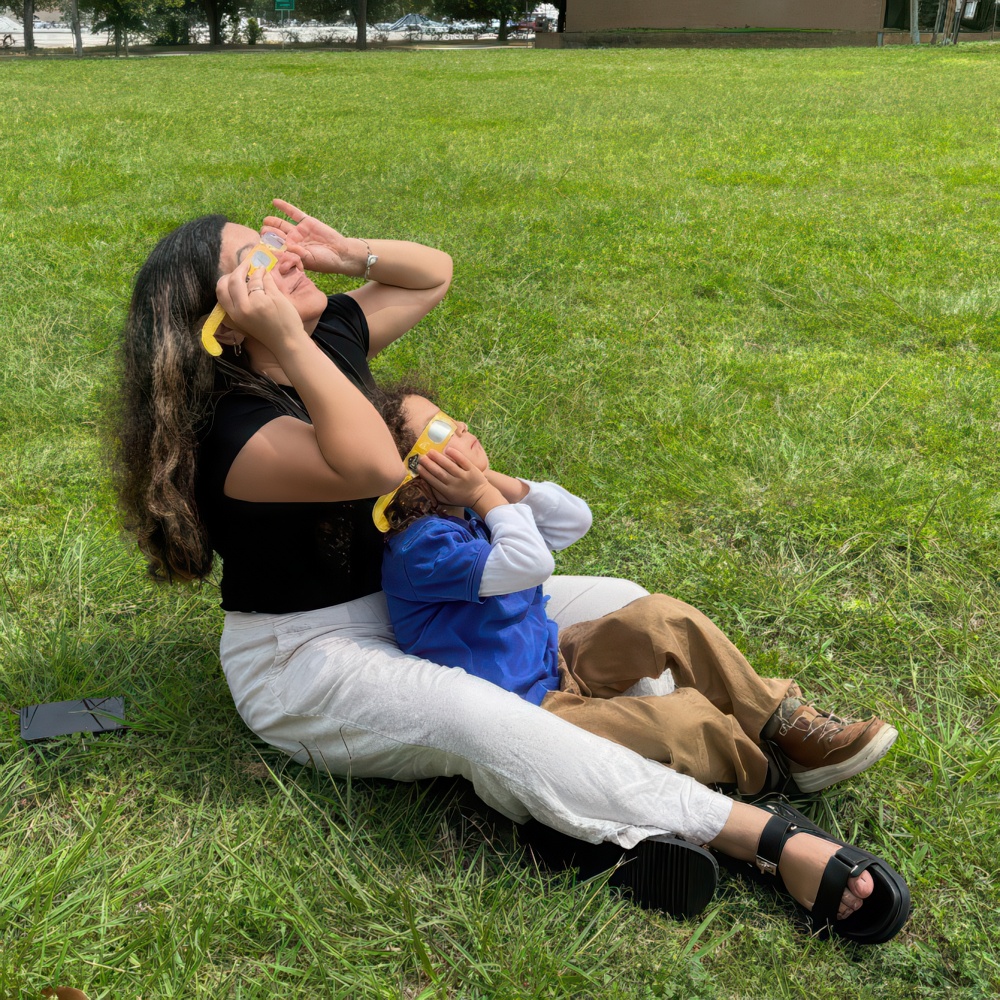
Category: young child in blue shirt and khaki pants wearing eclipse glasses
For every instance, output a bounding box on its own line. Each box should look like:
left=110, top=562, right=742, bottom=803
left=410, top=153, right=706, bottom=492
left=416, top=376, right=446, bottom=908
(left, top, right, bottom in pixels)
left=375, top=394, right=896, bottom=793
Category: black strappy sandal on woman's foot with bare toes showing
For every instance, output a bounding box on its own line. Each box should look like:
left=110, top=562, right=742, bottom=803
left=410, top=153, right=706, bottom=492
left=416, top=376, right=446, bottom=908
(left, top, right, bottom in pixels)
left=719, top=796, right=910, bottom=944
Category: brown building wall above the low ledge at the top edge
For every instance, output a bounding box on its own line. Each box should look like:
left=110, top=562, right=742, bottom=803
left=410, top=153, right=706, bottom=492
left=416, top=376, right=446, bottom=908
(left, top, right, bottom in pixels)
left=566, top=0, right=885, bottom=31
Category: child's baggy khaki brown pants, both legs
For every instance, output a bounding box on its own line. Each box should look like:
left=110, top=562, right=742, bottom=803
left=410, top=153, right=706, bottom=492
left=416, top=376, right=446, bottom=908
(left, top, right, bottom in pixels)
left=542, top=594, right=798, bottom=793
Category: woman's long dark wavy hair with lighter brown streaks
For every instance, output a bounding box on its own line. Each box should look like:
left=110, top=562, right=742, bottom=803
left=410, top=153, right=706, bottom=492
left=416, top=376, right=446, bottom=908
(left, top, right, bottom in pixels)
left=113, top=215, right=304, bottom=580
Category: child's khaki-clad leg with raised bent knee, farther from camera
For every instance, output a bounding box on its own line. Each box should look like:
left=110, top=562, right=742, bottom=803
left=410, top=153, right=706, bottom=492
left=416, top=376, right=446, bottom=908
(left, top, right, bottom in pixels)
left=559, top=594, right=798, bottom=743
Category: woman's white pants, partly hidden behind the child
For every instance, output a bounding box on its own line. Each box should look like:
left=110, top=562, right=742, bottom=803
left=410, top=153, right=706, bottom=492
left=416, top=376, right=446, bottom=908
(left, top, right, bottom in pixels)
left=221, top=576, right=732, bottom=847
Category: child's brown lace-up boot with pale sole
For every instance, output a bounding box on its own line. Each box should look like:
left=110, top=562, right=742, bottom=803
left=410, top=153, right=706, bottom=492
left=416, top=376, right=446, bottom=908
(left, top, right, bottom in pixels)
left=761, top=698, right=899, bottom=792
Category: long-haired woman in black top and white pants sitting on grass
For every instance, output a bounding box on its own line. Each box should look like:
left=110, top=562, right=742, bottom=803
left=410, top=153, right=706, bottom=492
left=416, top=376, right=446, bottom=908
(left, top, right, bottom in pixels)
left=118, top=200, right=908, bottom=942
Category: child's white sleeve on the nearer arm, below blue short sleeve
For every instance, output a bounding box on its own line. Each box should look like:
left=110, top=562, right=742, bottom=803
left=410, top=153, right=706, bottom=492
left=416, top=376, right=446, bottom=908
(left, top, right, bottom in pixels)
left=479, top=503, right=556, bottom=597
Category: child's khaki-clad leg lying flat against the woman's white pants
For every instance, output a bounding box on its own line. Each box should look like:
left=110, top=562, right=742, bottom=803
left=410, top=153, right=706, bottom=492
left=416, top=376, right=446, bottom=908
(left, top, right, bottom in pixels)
left=542, top=688, right=768, bottom=793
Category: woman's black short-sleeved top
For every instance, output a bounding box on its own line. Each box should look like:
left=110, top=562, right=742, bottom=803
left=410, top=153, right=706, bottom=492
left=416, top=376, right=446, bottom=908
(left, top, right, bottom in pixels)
left=197, top=295, right=383, bottom=614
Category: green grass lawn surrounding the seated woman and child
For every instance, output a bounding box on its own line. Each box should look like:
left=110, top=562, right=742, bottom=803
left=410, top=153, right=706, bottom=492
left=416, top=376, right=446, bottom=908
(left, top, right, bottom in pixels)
left=0, top=44, right=1000, bottom=1000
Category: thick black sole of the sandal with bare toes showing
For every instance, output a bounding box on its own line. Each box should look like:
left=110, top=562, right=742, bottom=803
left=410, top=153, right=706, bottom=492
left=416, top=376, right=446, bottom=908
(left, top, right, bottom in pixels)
left=719, top=796, right=910, bottom=944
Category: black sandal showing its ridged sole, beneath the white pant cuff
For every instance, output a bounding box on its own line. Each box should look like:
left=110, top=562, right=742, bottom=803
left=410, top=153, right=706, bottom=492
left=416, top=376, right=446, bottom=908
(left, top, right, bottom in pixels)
left=519, top=822, right=719, bottom=918
